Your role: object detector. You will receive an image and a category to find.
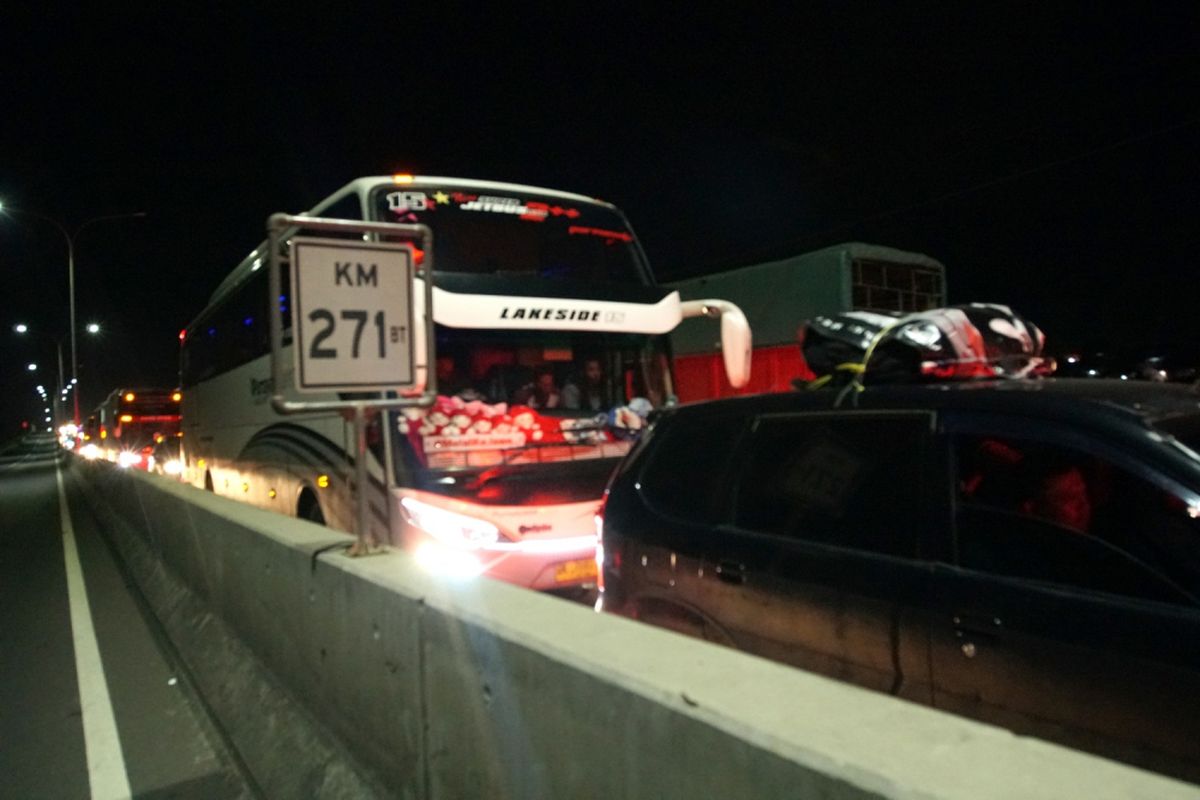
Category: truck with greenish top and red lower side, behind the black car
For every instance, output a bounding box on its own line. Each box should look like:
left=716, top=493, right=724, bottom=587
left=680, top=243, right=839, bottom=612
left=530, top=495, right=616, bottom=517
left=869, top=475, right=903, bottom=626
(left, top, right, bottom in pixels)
left=667, top=242, right=947, bottom=402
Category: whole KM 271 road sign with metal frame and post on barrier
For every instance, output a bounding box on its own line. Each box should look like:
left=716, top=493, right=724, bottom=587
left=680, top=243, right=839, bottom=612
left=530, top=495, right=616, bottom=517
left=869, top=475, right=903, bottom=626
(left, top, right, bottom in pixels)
left=266, top=213, right=437, bottom=555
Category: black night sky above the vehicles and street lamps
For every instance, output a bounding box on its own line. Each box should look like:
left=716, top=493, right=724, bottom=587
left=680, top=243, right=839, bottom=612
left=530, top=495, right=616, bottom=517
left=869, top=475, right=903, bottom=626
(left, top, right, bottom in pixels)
left=0, top=2, right=1200, bottom=438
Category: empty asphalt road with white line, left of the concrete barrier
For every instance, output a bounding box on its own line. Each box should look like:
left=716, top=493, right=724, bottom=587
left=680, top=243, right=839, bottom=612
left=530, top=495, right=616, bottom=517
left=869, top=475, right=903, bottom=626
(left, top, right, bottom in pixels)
left=0, top=435, right=258, bottom=800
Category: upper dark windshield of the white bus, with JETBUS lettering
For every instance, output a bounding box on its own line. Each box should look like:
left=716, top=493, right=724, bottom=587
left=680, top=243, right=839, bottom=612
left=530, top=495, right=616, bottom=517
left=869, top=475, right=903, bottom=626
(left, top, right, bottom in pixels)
left=372, top=184, right=649, bottom=283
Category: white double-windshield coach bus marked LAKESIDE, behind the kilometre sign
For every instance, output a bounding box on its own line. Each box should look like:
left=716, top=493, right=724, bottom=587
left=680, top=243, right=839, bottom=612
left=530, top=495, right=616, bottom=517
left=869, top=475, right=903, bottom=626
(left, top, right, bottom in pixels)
left=180, top=176, right=750, bottom=589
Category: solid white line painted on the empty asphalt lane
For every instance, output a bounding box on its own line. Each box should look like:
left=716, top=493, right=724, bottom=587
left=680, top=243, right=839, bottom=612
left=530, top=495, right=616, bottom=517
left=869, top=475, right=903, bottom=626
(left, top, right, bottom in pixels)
left=54, top=467, right=132, bottom=800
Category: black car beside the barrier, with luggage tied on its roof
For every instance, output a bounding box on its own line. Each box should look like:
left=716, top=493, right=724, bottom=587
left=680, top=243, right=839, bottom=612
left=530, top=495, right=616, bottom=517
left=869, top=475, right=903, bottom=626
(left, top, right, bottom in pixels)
left=598, top=379, right=1200, bottom=781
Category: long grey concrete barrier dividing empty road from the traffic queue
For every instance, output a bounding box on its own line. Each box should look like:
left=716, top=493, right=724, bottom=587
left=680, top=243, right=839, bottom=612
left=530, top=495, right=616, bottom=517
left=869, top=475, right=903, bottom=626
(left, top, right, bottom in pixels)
left=74, top=465, right=1200, bottom=800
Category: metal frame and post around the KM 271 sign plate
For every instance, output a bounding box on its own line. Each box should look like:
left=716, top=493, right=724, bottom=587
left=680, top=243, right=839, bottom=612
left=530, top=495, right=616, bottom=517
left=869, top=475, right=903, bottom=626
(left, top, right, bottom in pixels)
left=266, top=213, right=438, bottom=555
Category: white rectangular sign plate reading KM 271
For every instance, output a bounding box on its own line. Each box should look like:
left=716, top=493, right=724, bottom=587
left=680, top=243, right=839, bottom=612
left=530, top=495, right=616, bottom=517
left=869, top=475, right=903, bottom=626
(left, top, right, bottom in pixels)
left=290, top=236, right=414, bottom=392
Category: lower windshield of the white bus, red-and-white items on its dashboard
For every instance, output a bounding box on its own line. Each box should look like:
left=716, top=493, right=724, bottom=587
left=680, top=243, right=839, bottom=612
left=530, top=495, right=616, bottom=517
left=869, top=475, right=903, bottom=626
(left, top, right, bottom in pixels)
left=390, top=326, right=673, bottom=505
